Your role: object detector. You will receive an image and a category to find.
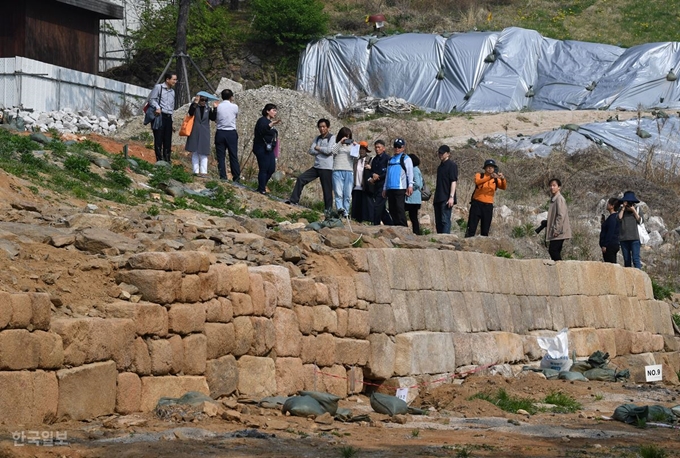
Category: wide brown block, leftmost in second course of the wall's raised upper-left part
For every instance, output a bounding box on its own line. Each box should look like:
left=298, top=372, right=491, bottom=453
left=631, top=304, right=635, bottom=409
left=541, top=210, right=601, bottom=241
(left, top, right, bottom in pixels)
left=116, top=270, right=182, bottom=305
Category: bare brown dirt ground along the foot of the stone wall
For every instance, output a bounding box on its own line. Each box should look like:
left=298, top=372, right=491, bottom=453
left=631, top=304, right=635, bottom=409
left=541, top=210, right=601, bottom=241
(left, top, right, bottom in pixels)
left=0, top=374, right=680, bottom=458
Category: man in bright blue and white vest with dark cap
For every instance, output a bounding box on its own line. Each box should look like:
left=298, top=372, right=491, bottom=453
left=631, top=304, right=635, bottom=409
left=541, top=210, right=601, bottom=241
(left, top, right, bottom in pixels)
left=383, top=138, right=413, bottom=226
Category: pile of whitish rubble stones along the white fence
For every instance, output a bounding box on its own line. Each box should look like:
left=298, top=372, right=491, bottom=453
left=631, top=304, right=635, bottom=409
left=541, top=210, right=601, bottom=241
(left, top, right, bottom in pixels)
left=1, top=107, right=125, bottom=135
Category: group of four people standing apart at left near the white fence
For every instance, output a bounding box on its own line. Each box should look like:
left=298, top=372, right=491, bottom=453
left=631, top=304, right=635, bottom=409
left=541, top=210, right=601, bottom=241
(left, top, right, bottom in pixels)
left=149, top=73, right=281, bottom=194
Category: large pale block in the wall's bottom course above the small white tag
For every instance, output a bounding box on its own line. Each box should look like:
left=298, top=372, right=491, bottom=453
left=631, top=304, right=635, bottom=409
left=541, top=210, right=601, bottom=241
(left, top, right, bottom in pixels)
left=394, top=331, right=456, bottom=375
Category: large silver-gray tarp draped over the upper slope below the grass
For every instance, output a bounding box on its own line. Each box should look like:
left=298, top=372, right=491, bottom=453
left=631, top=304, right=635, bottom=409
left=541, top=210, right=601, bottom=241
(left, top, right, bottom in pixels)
left=297, top=27, right=680, bottom=112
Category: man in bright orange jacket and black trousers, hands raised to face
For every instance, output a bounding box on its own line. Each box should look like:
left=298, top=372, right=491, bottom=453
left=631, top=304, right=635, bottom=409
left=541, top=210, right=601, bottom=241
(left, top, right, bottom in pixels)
left=465, top=159, right=507, bottom=237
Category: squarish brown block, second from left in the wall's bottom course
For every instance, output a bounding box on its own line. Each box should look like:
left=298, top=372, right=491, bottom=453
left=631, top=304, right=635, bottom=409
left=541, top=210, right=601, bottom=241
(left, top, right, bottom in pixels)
left=57, top=361, right=118, bottom=420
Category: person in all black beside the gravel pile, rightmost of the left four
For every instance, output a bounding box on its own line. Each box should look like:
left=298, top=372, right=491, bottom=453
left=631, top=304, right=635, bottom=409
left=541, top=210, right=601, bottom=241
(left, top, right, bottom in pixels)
left=253, top=103, right=281, bottom=194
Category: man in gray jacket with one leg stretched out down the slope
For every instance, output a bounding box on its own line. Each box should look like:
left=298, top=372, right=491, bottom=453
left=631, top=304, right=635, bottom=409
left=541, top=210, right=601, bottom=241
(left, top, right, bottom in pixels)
left=286, top=118, right=335, bottom=213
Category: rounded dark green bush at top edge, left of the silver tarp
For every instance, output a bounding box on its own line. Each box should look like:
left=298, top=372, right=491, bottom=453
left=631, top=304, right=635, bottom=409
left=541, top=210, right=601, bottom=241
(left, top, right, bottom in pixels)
left=250, top=0, right=328, bottom=51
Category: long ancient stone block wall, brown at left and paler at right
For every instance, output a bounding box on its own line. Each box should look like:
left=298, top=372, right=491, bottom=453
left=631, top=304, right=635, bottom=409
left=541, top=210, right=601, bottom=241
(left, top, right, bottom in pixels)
left=0, top=249, right=680, bottom=425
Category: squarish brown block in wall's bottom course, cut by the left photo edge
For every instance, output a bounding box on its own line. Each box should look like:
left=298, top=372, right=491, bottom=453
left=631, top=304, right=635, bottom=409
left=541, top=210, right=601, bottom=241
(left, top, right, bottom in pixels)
left=0, top=370, right=59, bottom=427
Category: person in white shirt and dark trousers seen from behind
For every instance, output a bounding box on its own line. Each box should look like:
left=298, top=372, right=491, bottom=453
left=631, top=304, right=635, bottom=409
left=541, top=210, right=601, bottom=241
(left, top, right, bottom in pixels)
left=210, top=89, right=241, bottom=183
